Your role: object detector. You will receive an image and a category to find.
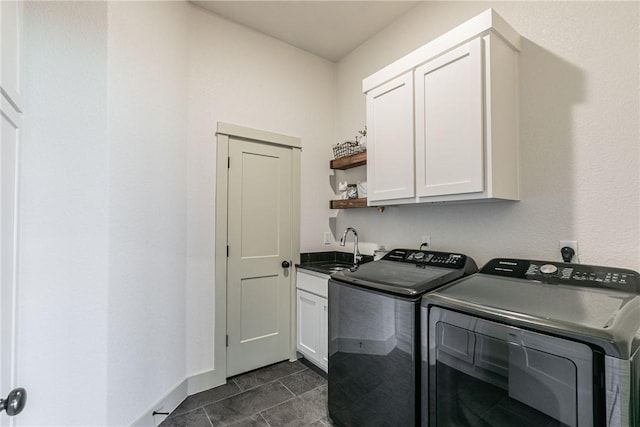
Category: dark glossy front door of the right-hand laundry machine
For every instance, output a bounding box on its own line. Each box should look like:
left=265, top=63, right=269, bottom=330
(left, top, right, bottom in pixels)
left=423, top=307, right=594, bottom=427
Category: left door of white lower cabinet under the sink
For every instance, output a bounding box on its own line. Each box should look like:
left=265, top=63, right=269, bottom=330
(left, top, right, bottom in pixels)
left=297, top=290, right=321, bottom=364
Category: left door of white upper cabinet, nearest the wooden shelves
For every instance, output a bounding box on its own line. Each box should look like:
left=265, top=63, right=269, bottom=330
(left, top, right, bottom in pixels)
left=367, top=72, right=414, bottom=202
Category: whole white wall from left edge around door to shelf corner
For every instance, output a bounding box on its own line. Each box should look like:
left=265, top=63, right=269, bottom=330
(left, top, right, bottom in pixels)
left=19, top=2, right=335, bottom=425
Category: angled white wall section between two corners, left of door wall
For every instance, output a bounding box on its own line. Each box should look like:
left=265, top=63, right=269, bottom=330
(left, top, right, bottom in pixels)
left=107, top=2, right=188, bottom=426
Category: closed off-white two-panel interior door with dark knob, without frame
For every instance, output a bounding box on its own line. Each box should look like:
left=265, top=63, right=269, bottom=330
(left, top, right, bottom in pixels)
left=227, top=139, right=293, bottom=376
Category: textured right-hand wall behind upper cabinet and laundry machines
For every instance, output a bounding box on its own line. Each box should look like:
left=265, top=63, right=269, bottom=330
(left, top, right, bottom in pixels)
left=336, top=2, right=640, bottom=269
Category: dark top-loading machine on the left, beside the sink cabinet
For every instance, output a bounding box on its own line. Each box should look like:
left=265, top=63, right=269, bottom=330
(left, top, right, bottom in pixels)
left=328, top=249, right=477, bottom=426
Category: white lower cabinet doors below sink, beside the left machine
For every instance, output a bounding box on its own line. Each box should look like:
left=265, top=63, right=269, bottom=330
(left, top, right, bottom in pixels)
left=297, top=289, right=328, bottom=371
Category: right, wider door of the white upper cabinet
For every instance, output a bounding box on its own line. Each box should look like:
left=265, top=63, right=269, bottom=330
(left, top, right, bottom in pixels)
left=415, top=38, right=484, bottom=197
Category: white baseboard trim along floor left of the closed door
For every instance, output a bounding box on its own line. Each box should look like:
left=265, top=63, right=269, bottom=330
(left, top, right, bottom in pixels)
left=130, top=369, right=227, bottom=427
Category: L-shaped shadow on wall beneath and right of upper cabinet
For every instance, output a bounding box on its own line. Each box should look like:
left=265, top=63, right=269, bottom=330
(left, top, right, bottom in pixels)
left=330, top=39, right=586, bottom=261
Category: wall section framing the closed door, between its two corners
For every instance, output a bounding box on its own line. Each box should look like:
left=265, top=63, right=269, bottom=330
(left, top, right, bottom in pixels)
left=187, top=6, right=335, bottom=375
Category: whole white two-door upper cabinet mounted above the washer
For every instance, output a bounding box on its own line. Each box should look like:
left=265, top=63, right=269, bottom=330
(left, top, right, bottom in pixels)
left=363, top=9, right=520, bottom=205
